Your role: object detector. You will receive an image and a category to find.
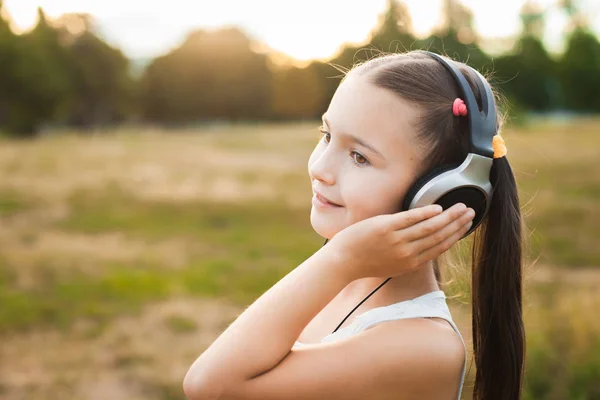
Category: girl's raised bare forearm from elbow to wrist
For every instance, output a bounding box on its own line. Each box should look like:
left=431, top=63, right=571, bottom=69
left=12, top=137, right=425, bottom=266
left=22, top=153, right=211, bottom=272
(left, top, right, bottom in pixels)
left=184, top=246, right=353, bottom=399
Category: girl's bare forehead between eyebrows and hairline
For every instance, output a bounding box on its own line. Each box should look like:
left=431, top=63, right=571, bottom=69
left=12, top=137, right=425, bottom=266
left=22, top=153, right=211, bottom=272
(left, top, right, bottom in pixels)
left=325, top=73, right=420, bottom=162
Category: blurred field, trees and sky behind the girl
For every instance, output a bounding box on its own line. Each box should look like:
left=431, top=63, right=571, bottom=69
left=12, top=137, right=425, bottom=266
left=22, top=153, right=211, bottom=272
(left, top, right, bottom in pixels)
left=0, top=0, right=600, bottom=400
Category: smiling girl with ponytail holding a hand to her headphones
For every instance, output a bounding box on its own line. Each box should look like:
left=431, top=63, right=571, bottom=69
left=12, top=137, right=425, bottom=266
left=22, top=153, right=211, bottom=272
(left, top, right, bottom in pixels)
left=184, top=52, right=525, bottom=400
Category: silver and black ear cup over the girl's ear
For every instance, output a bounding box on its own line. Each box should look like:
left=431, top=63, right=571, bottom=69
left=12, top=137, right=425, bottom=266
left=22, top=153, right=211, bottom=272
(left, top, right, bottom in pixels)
left=409, top=153, right=493, bottom=236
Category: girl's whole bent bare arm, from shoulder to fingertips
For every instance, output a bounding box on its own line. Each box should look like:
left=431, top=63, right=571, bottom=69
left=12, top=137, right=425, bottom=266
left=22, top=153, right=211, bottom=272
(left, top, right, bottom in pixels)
left=184, top=205, right=473, bottom=400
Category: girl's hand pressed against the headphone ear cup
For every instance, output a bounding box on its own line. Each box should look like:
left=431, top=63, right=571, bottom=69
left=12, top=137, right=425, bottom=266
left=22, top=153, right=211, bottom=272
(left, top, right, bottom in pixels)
left=325, top=203, right=475, bottom=280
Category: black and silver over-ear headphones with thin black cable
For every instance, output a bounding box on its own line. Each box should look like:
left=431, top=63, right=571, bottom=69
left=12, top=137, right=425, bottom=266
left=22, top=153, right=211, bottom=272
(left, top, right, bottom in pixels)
left=323, top=50, right=497, bottom=333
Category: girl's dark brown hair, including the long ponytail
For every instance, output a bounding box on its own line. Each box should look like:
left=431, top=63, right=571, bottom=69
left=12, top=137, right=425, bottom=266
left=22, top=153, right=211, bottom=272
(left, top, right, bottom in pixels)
left=352, top=52, right=525, bottom=400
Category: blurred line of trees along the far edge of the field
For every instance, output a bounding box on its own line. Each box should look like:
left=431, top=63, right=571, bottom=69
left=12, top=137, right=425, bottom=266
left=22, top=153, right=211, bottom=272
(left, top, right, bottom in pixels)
left=0, top=0, right=600, bottom=137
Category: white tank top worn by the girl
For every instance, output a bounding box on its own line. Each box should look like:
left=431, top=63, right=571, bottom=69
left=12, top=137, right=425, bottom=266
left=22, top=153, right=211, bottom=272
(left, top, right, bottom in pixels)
left=293, top=290, right=467, bottom=400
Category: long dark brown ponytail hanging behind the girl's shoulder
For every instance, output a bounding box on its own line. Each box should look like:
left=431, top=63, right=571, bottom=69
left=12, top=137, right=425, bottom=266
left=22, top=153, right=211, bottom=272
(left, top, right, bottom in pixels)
left=472, top=157, right=525, bottom=400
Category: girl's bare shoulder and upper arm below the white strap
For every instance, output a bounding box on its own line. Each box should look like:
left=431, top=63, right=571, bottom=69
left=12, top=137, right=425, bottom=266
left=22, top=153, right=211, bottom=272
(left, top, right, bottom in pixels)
left=213, top=318, right=465, bottom=400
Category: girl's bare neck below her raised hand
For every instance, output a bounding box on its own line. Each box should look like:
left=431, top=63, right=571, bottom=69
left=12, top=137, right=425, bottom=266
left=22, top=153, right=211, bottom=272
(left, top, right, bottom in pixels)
left=340, top=261, right=440, bottom=305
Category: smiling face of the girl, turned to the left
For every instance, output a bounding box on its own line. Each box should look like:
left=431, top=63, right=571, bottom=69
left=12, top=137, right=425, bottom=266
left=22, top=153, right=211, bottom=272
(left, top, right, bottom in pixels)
left=308, top=72, right=424, bottom=239
